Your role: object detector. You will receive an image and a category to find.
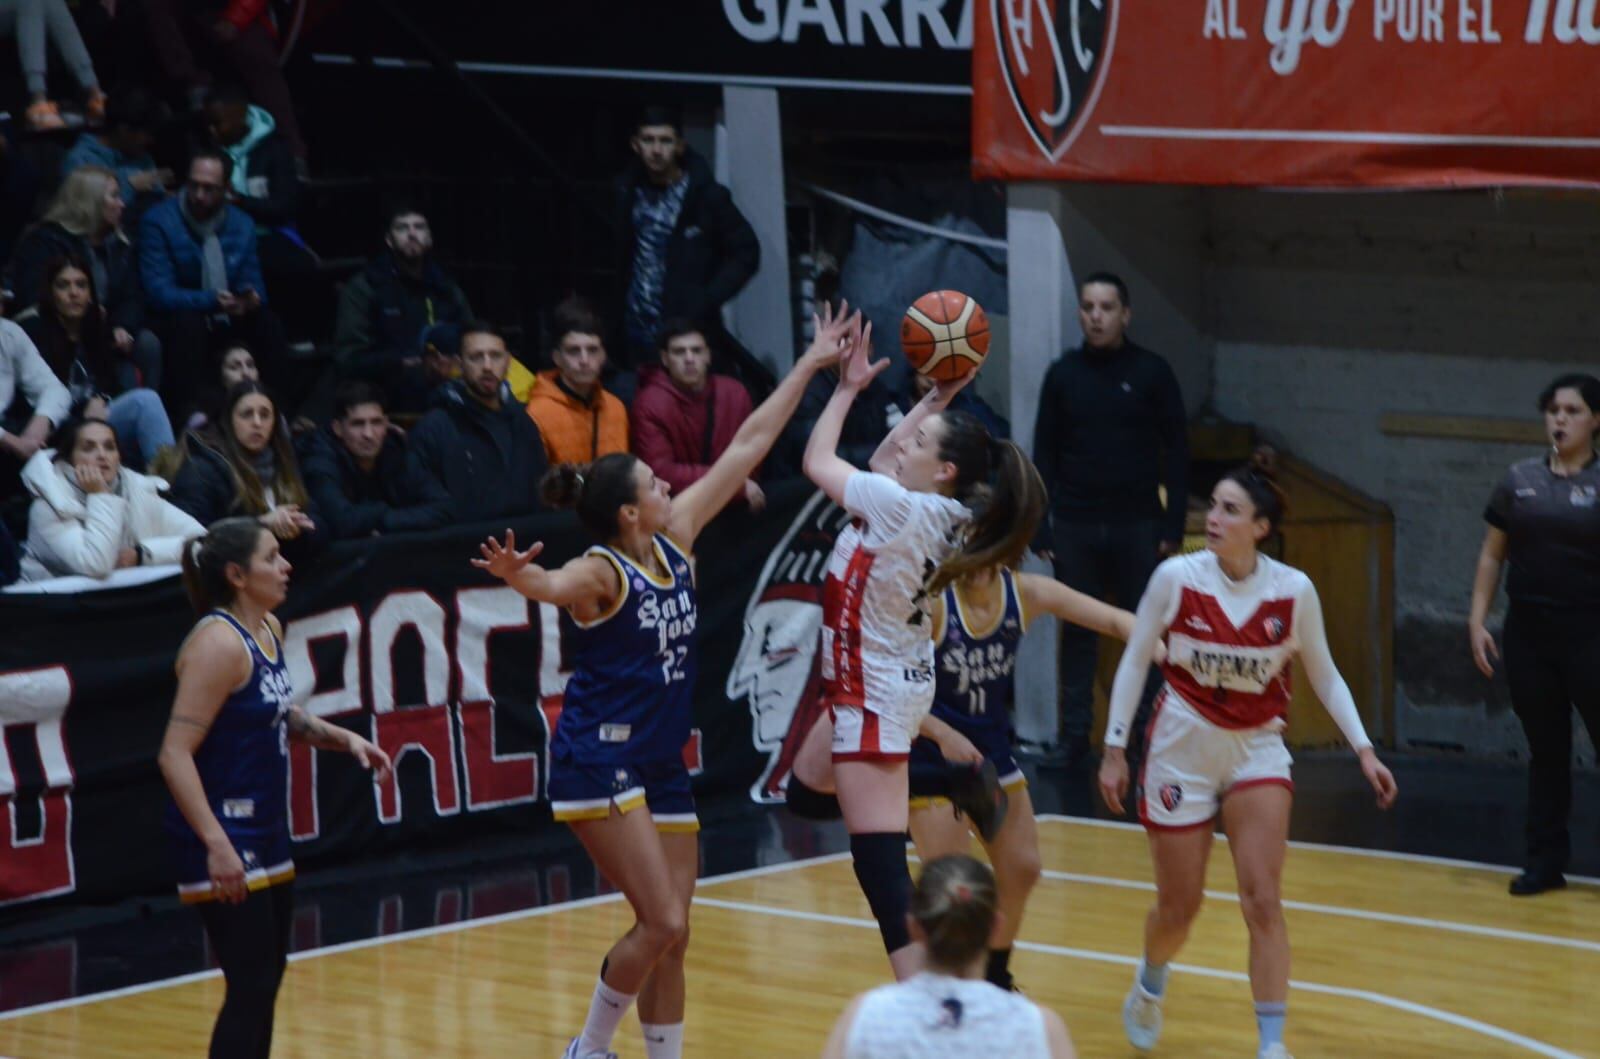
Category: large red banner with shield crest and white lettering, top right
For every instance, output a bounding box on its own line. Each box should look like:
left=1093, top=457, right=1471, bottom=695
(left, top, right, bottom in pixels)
left=973, top=0, right=1600, bottom=187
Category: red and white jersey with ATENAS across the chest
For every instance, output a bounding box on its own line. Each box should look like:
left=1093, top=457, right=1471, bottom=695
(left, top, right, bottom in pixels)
left=1162, top=552, right=1310, bottom=728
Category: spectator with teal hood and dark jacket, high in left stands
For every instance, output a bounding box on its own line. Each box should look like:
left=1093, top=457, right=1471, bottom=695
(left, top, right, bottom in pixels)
left=205, top=85, right=306, bottom=251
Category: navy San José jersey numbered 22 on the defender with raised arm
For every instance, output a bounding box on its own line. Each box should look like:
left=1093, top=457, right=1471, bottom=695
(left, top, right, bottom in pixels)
left=550, top=533, right=699, bottom=765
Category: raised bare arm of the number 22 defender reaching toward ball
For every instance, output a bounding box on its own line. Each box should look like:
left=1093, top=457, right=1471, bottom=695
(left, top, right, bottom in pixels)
left=667, top=306, right=861, bottom=552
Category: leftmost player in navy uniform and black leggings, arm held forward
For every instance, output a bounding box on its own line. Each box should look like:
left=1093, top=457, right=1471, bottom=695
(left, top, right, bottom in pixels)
left=158, top=518, right=389, bottom=1059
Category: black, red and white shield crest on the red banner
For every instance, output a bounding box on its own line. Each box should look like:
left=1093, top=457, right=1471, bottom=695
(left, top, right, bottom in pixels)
left=989, top=0, right=1120, bottom=162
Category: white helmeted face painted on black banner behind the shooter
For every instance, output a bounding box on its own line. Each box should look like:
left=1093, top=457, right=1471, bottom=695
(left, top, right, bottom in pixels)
left=728, top=493, right=850, bottom=801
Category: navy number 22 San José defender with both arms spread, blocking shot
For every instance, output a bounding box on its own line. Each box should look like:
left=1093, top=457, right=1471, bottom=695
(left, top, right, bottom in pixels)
left=472, top=306, right=861, bottom=1059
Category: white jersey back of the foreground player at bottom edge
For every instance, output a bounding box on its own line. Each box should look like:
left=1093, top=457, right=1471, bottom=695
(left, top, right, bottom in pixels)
left=845, top=971, right=1050, bottom=1059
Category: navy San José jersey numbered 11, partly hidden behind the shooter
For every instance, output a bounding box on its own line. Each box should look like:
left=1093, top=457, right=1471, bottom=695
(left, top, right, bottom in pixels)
left=933, top=569, right=1027, bottom=737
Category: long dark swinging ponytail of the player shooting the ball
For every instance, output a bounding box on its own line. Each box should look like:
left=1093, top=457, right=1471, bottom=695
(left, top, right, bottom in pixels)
left=928, top=411, right=1046, bottom=592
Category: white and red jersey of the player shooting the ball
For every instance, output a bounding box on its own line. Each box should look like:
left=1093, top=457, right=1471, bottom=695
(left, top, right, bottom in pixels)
left=822, top=470, right=971, bottom=729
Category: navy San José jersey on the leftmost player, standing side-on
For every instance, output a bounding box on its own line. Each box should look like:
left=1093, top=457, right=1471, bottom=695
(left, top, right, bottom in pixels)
left=166, top=611, right=294, bottom=901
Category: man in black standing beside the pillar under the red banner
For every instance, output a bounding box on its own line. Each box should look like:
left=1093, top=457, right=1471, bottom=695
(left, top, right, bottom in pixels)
left=1034, top=272, right=1189, bottom=760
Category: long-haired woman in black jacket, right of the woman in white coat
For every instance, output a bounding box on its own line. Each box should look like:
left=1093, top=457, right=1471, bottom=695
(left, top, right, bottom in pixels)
left=173, top=382, right=326, bottom=560
